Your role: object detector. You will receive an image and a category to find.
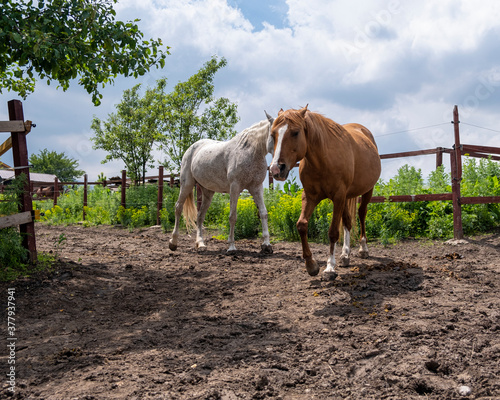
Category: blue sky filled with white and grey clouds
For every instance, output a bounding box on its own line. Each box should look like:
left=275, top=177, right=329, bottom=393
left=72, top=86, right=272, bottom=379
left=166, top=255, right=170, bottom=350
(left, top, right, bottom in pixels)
left=0, top=0, right=500, bottom=181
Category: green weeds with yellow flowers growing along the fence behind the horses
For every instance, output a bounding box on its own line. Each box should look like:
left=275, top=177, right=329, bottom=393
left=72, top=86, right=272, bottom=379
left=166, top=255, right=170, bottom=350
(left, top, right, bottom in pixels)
left=0, top=158, right=500, bottom=279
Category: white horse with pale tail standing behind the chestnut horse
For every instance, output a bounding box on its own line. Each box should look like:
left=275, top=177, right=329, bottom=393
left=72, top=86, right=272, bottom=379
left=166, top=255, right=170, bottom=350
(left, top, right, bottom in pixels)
left=169, top=112, right=274, bottom=253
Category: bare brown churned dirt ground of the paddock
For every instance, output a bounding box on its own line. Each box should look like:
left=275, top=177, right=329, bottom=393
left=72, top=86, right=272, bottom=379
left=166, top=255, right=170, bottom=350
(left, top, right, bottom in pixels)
left=0, top=224, right=500, bottom=400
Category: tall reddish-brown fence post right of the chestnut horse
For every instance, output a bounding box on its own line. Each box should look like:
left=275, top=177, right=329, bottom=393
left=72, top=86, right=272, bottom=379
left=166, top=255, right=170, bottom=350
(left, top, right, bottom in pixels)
left=450, top=106, right=464, bottom=239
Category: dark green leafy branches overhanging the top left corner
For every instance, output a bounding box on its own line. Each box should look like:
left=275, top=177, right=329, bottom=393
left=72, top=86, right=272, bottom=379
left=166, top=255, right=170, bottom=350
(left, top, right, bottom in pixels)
left=0, top=0, right=169, bottom=105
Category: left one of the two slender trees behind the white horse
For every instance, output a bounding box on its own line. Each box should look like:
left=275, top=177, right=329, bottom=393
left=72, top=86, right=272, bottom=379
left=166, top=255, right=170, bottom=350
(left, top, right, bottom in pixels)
left=91, top=84, right=158, bottom=183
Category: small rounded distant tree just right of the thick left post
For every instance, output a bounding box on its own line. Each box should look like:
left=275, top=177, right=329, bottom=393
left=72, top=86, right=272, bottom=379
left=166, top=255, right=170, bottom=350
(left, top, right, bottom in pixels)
left=29, top=149, right=85, bottom=182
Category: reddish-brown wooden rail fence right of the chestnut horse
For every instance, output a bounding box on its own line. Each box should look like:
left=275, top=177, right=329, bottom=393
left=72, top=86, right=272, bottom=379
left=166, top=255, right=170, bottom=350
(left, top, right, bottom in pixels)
left=269, top=106, right=500, bottom=239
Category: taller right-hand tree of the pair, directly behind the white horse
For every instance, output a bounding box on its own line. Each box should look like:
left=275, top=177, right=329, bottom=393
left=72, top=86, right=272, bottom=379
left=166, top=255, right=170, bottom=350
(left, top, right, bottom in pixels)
left=152, top=57, right=239, bottom=172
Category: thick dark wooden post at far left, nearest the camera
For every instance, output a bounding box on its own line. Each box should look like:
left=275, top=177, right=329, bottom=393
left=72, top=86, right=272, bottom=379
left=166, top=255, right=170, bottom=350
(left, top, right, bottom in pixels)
left=7, top=100, right=37, bottom=263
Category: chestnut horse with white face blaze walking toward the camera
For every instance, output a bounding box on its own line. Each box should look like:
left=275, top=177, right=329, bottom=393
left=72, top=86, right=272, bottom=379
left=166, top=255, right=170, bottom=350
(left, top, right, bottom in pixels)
left=269, top=106, right=381, bottom=279
